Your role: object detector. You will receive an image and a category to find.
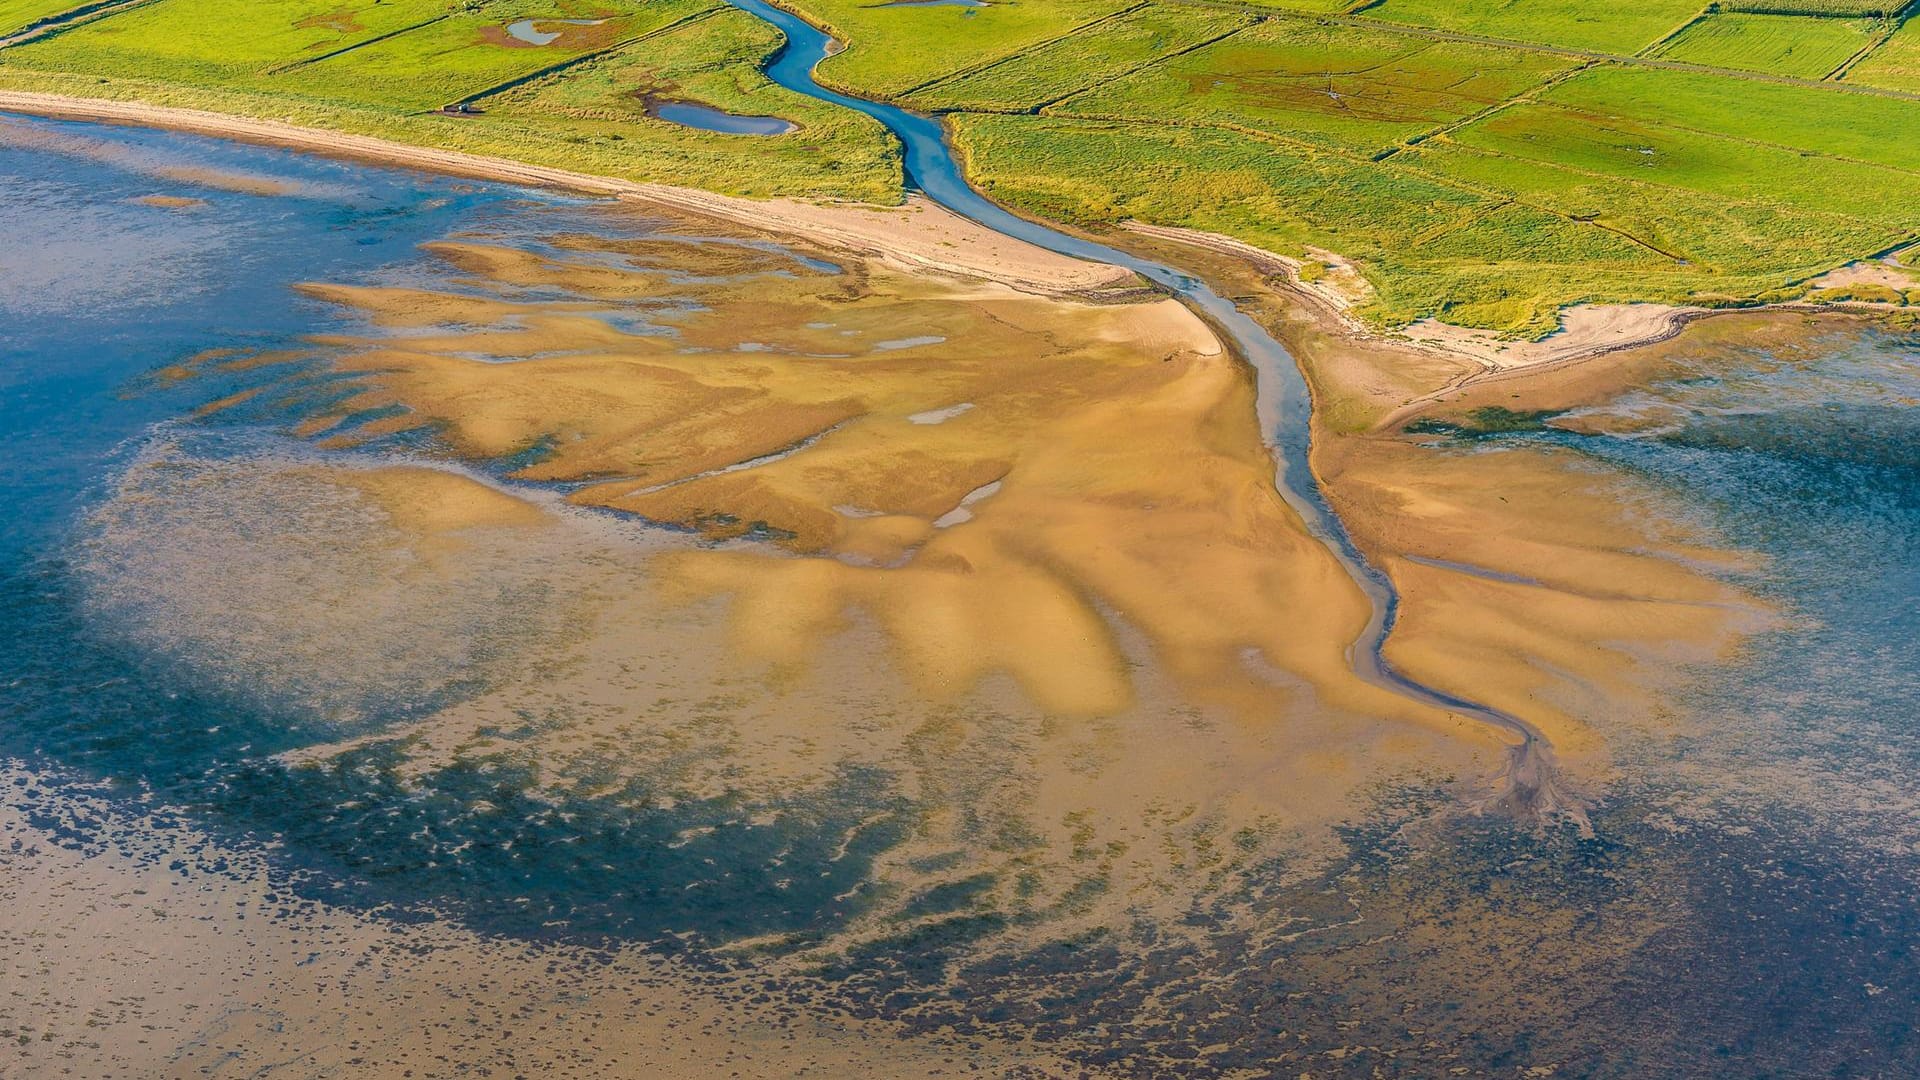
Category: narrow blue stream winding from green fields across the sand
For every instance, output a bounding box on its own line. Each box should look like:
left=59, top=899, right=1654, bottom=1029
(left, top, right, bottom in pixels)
left=728, top=0, right=1584, bottom=821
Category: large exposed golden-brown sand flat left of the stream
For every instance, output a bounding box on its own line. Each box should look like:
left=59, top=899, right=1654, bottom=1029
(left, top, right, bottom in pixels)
left=284, top=227, right=1438, bottom=734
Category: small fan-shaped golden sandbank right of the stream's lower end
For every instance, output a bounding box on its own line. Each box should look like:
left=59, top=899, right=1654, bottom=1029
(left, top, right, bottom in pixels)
left=1319, top=428, right=1768, bottom=771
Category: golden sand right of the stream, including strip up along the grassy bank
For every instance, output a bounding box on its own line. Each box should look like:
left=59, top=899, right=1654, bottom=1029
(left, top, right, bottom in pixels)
left=1135, top=222, right=1766, bottom=776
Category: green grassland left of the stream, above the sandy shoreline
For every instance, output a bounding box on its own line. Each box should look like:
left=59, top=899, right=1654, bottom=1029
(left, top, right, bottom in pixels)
left=0, top=0, right=900, bottom=204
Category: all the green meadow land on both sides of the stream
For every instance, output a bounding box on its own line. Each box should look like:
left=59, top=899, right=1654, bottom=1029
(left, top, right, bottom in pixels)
left=0, top=0, right=1920, bottom=334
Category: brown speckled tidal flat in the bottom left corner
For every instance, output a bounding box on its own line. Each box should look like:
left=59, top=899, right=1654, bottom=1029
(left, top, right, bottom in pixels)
left=0, top=771, right=1100, bottom=1080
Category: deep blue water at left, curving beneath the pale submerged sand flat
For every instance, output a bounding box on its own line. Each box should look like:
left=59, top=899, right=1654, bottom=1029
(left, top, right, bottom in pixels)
left=0, top=119, right=897, bottom=940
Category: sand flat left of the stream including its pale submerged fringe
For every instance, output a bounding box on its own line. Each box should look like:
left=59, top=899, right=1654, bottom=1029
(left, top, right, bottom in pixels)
left=96, top=212, right=1503, bottom=944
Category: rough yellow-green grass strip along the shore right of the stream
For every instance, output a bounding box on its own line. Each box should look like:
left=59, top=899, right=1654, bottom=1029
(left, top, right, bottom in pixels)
left=958, top=115, right=1699, bottom=332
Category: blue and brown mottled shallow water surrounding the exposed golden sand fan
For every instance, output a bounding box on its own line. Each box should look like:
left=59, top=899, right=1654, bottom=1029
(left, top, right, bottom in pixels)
left=0, top=109, right=1920, bottom=1076
